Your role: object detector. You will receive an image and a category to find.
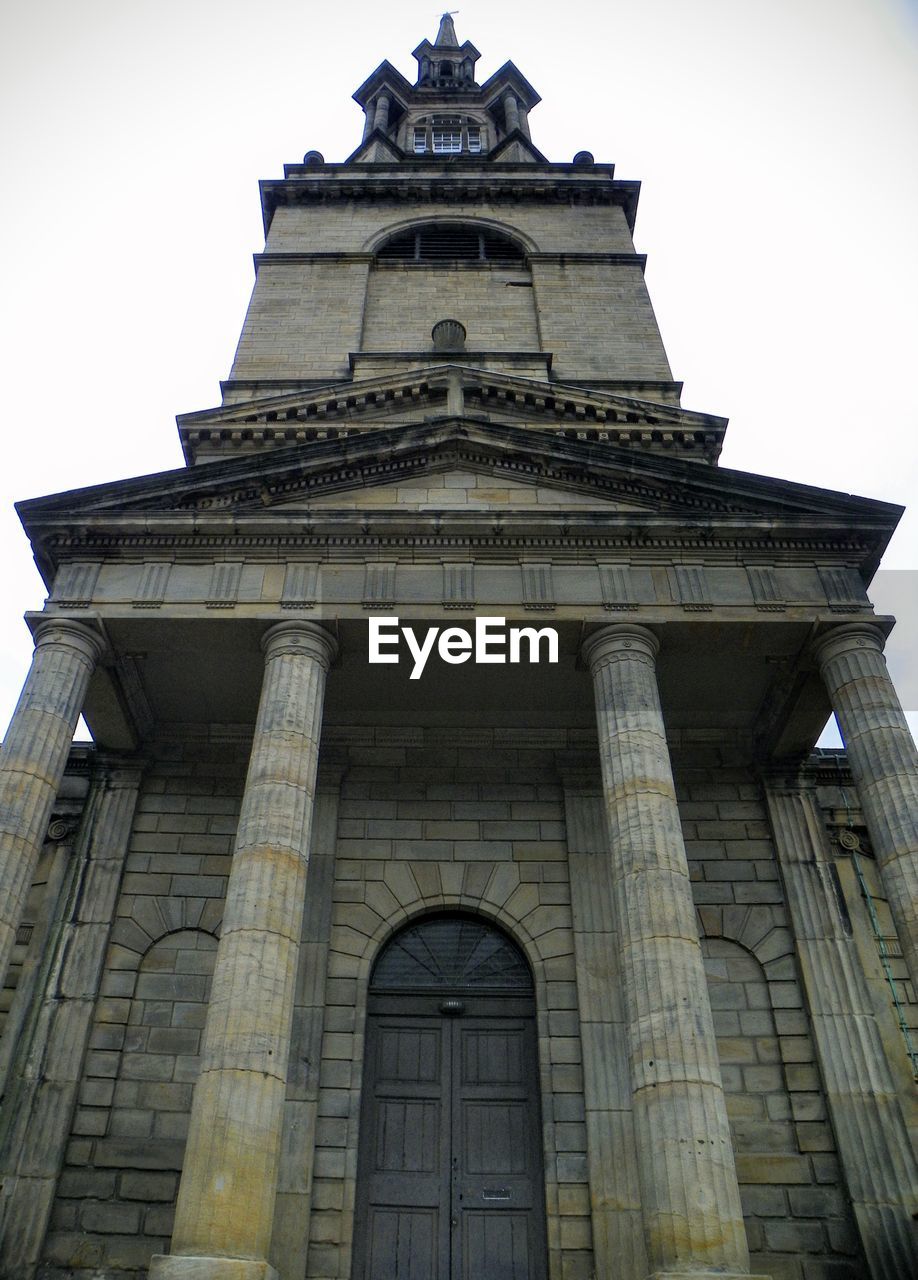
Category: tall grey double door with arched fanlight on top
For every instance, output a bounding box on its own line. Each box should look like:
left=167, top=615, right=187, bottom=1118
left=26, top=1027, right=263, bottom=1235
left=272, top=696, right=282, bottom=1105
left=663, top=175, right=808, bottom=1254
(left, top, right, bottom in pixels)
left=353, top=915, right=547, bottom=1280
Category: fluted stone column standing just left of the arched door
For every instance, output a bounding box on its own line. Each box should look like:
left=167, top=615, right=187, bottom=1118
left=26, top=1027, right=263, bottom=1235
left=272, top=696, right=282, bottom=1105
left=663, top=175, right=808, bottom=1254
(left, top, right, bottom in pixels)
left=150, top=622, right=335, bottom=1280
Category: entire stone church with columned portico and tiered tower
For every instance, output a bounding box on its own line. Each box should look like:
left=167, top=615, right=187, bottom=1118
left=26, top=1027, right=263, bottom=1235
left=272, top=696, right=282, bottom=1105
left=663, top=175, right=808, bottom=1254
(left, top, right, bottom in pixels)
left=0, top=15, right=918, bottom=1280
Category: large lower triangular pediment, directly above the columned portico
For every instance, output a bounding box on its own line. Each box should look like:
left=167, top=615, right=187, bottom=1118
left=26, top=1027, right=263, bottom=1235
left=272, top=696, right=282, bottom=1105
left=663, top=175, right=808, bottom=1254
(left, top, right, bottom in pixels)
left=17, top=417, right=901, bottom=582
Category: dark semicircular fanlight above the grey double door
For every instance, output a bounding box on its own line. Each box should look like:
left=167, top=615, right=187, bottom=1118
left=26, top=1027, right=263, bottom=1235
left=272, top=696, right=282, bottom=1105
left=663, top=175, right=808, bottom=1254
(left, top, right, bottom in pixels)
left=370, top=915, right=533, bottom=992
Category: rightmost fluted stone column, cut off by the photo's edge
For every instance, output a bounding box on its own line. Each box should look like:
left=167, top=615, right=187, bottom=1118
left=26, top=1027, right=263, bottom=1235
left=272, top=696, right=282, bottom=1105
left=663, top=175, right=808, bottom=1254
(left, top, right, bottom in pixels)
left=816, top=622, right=918, bottom=982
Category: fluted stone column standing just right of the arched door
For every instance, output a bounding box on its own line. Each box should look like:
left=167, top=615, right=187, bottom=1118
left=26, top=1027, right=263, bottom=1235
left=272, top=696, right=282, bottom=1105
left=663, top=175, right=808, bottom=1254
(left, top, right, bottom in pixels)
left=584, top=623, right=763, bottom=1280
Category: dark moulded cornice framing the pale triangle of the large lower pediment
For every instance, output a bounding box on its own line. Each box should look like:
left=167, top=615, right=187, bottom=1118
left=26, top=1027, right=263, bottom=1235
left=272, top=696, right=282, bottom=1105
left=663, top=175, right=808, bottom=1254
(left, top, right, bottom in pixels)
left=18, top=417, right=901, bottom=563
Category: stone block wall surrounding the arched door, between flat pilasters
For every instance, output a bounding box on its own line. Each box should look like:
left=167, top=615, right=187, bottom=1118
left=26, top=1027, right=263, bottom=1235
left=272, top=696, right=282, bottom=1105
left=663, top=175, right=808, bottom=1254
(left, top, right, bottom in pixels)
left=306, top=730, right=593, bottom=1280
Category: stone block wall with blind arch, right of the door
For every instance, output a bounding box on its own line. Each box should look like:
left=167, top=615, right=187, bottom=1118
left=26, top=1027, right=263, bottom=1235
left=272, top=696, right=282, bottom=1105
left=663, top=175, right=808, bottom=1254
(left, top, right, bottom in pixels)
left=677, top=763, right=864, bottom=1280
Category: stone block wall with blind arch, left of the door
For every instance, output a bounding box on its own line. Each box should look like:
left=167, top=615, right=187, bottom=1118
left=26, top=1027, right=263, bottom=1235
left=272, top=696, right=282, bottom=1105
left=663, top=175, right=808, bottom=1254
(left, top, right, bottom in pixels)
left=41, top=735, right=248, bottom=1280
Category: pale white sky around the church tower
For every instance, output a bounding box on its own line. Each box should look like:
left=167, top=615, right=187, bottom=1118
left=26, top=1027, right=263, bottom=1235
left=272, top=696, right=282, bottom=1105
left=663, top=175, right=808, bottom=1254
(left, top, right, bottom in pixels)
left=0, top=0, right=918, bottom=747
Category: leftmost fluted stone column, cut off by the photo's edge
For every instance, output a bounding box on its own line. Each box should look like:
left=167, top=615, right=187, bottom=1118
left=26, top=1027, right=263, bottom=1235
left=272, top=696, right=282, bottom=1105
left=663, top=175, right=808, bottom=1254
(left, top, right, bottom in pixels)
left=0, top=618, right=102, bottom=982
